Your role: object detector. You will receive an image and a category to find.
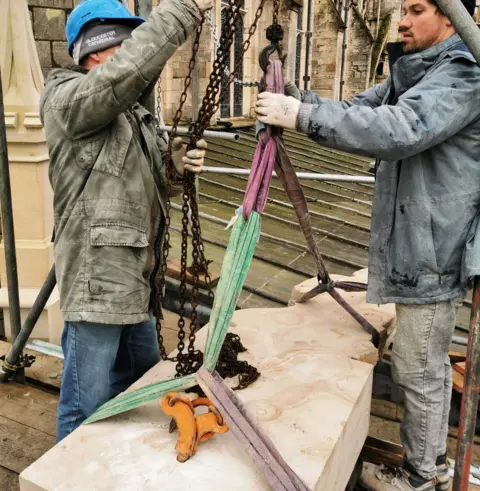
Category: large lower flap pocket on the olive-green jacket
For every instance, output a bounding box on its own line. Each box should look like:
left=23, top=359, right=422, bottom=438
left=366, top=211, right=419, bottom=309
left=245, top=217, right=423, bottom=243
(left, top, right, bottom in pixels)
left=87, top=221, right=150, bottom=306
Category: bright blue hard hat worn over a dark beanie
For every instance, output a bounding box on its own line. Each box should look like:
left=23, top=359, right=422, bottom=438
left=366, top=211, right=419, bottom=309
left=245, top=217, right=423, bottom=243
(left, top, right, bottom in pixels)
left=66, top=0, right=145, bottom=56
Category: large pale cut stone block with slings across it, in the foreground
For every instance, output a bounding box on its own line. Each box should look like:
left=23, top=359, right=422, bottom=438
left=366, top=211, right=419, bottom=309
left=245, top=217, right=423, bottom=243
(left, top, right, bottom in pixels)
left=20, top=270, right=393, bottom=491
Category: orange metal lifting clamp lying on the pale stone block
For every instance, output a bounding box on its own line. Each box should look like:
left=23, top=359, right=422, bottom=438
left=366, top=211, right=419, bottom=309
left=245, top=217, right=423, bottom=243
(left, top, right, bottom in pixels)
left=162, top=392, right=228, bottom=462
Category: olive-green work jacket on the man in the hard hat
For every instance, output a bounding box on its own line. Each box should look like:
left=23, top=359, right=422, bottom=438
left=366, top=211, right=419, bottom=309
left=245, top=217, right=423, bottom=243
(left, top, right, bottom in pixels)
left=40, top=0, right=200, bottom=324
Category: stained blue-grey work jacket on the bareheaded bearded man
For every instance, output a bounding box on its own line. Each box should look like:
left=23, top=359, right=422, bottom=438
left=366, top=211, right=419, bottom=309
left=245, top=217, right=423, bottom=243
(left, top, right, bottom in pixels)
left=297, top=35, right=480, bottom=304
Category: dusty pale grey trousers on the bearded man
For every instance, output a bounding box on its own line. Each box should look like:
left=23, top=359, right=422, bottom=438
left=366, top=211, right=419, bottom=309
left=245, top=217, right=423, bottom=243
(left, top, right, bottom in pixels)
left=392, top=300, right=458, bottom=479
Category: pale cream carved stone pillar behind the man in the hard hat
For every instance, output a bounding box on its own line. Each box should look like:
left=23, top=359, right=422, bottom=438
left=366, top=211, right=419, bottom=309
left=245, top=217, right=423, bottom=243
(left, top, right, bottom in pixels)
left=0, top=0, right=62, bottom=342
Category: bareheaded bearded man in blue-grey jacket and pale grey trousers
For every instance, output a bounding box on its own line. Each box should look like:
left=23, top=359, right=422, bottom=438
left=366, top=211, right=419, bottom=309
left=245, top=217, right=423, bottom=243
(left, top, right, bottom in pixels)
left=256, top=0, right=480, bottom=491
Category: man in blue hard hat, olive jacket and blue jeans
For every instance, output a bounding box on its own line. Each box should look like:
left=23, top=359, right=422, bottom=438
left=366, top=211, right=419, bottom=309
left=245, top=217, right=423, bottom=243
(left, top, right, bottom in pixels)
left=40, top=0, right=212, bottom=441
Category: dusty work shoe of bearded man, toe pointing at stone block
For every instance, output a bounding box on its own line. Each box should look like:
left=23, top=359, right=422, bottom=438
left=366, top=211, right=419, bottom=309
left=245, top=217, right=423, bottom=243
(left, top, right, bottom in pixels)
left=360, top=463, right=436, bottom=491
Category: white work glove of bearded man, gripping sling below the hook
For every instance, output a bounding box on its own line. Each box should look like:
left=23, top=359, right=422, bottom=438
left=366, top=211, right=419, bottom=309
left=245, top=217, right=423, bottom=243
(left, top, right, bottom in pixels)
left=255, top=92, right=302, bottom=130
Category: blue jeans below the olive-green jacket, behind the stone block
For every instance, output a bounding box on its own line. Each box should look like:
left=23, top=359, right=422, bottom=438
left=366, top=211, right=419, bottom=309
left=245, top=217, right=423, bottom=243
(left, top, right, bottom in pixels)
left=57, top=317, right=160, bottom=442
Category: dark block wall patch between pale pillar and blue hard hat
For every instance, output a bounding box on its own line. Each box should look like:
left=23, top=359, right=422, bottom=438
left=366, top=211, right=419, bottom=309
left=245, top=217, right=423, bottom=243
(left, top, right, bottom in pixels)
left=28, top=0, right=74, bottom=74
